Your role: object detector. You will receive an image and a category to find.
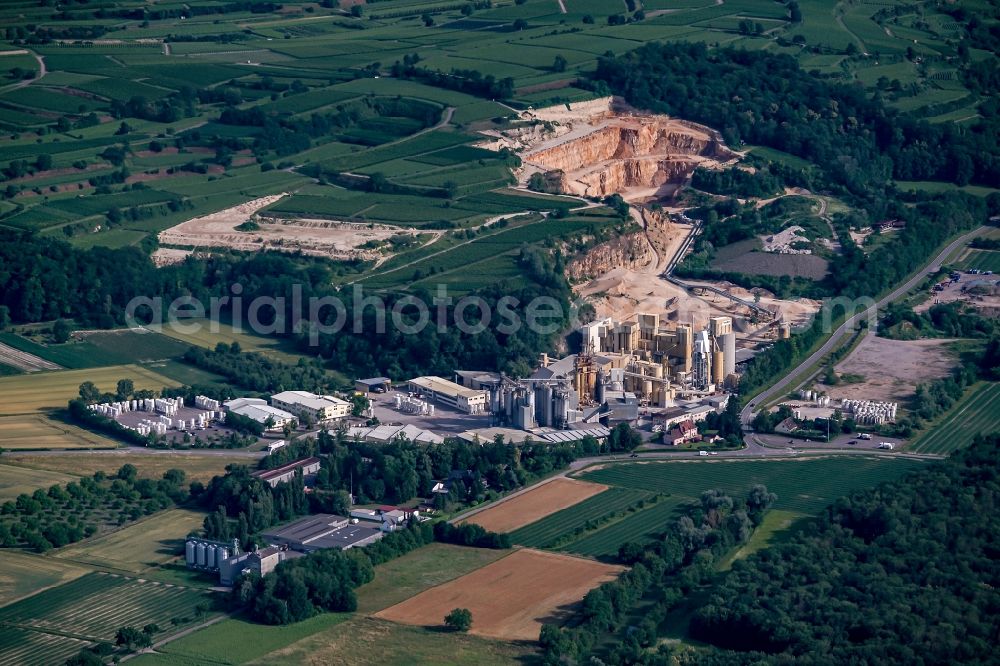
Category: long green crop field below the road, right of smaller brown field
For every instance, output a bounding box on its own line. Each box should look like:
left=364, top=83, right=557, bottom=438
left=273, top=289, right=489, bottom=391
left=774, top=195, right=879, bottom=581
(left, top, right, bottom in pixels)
left=547, top=456, right=923, bottom=558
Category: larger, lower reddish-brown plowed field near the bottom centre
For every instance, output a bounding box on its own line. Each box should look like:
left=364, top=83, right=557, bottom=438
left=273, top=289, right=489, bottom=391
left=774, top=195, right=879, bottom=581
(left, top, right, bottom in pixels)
left=376, top=548, right=622, bottom=641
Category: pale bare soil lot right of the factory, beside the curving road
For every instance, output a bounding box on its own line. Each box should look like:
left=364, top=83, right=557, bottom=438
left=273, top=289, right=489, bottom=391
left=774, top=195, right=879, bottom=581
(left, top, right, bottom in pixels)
left=824, top=335, right=955, bottom=403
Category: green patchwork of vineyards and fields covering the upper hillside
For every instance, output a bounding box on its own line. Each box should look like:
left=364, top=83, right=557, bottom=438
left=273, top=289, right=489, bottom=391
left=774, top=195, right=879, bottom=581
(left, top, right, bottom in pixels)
left=0, top=0, right=976, bottom=252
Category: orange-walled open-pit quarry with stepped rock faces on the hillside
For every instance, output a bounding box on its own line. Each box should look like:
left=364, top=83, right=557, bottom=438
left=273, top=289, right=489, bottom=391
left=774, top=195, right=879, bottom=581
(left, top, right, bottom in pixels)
left=486, top=97, right=739, bottom=201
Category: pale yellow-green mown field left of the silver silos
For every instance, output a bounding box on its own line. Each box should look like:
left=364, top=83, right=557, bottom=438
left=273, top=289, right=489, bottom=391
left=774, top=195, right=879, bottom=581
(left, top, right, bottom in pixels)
left=54, top=509, right=205, bottom=573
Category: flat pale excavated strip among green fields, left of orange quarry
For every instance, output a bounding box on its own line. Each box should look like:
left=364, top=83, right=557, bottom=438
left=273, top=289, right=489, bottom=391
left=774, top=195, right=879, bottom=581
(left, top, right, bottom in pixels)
left=153, top=194, right=416, bottom=265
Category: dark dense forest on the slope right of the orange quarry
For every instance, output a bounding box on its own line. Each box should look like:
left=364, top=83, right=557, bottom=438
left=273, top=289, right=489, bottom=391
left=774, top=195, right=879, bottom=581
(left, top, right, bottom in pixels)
left=595, top=43, right=1000, bottom=195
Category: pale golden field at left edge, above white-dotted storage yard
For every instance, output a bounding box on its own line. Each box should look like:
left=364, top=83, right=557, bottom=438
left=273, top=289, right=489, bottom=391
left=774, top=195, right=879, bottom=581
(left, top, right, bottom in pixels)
left=0, top=365, right=180, bottom=416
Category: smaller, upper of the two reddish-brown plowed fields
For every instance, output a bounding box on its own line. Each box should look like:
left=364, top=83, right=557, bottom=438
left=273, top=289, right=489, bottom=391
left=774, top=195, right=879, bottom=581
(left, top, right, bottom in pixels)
left=458, top=478, right=607, bottom=532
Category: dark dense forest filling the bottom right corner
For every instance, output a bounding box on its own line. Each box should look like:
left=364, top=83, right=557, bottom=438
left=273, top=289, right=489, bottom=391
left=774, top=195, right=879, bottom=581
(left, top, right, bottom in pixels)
left=691, top=434, right=1000, bottom=664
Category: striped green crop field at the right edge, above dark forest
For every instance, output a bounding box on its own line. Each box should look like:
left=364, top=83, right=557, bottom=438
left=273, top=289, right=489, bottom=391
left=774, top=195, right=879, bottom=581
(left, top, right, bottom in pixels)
left=909, top=382, right=1000, bottom=455
